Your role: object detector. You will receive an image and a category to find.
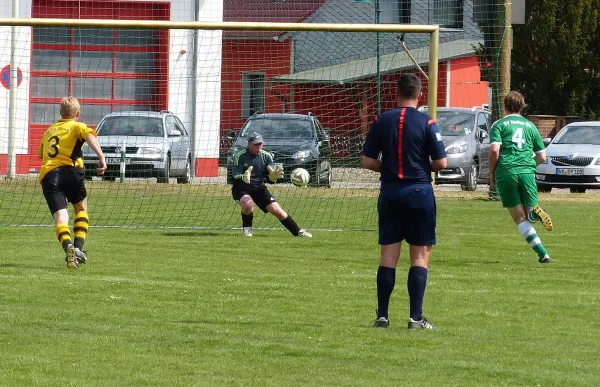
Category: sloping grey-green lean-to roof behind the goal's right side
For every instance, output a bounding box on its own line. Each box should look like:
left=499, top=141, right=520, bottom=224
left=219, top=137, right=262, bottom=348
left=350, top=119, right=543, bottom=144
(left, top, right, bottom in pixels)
left=271, top=39, right=482, bottom=85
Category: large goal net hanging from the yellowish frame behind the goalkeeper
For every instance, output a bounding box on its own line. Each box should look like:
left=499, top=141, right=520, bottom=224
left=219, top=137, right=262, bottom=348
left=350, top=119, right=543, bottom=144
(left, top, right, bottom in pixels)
left=0, top=0, right=496, bottom=229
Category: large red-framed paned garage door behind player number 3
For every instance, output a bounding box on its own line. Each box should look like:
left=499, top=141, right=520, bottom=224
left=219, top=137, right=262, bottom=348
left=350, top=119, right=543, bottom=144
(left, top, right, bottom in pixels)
left=31, top=27, right=166, bottom=126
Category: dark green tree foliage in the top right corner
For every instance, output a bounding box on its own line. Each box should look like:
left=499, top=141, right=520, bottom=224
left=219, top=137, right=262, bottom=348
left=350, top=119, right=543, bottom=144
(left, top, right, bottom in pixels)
left=511, top=0, right=600, bottom=119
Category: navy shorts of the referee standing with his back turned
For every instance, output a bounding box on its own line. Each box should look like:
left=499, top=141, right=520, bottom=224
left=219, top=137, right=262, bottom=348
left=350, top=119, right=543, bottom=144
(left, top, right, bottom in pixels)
left=377, top=183, right=436, bottom=246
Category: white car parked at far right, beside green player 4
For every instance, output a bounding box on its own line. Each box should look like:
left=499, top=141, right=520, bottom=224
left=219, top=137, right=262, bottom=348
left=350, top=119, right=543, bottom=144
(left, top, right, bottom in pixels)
left=535, top=121, right=600, bottom=193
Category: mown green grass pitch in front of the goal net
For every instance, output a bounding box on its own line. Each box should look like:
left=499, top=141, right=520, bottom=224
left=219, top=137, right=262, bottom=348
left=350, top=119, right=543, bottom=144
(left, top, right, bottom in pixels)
left=0, top=199, right=600, bottom=386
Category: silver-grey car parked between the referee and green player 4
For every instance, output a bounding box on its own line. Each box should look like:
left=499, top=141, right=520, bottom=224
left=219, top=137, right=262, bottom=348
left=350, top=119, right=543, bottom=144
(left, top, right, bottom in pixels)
left=419, top=106, right=491, bottom=191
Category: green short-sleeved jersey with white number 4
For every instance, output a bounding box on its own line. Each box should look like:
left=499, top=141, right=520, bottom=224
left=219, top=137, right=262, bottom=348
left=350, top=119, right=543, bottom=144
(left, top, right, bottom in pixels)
left=490, top=114, right=544, bottom=178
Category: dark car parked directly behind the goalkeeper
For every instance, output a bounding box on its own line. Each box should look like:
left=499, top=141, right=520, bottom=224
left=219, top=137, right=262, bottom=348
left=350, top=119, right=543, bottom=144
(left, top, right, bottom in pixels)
left=227, top=113, right=333, bottom=187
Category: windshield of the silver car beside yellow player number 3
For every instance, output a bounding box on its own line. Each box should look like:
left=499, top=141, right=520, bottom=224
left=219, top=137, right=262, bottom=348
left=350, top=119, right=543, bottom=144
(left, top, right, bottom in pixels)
left=97, top=116, right=164, bottom=137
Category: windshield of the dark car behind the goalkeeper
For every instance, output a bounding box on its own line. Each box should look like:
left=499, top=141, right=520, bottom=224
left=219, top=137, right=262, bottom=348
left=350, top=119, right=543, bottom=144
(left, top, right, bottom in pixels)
left=241, top=118, right=314, bottom=140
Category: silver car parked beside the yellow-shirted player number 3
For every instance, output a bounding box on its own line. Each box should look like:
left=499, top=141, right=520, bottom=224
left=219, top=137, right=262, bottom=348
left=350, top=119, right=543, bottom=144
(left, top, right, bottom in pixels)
left=83, top=111, right=192, bottom=184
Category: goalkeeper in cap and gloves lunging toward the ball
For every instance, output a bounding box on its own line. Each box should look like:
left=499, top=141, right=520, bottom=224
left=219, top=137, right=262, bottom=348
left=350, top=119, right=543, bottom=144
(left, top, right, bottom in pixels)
left=231, top=132, right=312, bottom=238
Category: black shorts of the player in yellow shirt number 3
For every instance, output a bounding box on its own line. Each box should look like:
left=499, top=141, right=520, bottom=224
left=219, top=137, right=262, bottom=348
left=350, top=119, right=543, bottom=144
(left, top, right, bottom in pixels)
left=42, top=166, right=87, bottom=214
